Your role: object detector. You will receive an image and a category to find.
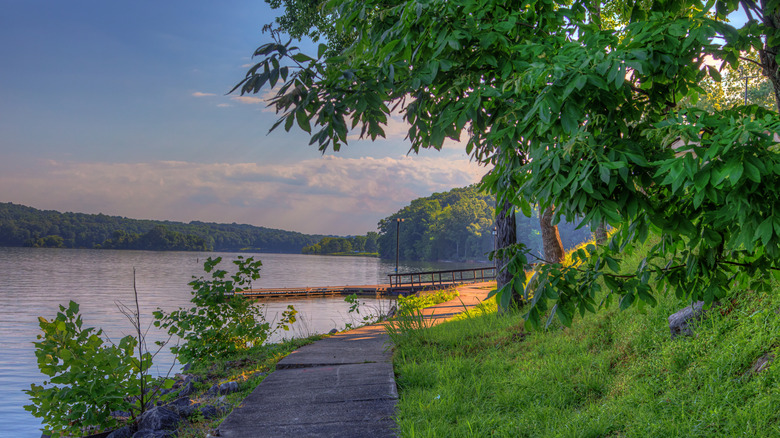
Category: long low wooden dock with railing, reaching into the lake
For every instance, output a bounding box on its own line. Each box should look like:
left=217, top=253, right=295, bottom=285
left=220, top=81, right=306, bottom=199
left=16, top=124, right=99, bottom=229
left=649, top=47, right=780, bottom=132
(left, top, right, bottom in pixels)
left=239, top=267, right=495, bottom=299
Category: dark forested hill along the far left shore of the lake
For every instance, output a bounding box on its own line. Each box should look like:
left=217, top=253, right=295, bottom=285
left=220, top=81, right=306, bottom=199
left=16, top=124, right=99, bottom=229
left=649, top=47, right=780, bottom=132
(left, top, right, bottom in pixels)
left=0, top=203, right=325, bottom=253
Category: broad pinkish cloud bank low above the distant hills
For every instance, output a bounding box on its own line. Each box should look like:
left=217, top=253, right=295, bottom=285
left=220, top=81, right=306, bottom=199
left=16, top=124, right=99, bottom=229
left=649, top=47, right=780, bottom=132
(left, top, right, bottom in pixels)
left=0, top=154, right=486, bottom=235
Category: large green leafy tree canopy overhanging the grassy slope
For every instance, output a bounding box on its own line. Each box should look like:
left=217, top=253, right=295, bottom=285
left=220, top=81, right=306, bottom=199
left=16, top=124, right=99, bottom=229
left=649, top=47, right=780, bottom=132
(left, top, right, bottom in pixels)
left=234, top=0, right=780, bottom=324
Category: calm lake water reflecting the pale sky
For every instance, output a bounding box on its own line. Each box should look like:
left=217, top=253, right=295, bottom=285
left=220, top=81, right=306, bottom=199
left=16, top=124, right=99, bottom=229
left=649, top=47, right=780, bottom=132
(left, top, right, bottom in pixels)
left=0, top=247, right=482, bottom=438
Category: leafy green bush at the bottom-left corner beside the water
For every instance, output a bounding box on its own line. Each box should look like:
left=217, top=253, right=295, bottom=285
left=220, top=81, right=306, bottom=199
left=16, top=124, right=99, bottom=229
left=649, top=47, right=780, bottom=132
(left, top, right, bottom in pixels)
left=24, top=301, right=152, bottom=437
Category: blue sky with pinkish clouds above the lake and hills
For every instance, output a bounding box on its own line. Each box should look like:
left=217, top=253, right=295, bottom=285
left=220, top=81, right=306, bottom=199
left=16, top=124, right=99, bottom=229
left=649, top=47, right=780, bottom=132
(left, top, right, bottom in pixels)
left=0, top=0, right=486, bottom=235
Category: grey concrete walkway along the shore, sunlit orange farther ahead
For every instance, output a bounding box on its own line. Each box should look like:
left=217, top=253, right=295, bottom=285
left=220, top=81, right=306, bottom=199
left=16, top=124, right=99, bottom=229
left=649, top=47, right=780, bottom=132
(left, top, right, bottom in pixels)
left=219, top=283, right=495, bottom=438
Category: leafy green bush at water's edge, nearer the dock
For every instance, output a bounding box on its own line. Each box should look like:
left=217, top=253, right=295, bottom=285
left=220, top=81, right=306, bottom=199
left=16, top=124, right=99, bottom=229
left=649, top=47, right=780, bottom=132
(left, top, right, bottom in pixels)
left=154, top=256, right=297, bottom=363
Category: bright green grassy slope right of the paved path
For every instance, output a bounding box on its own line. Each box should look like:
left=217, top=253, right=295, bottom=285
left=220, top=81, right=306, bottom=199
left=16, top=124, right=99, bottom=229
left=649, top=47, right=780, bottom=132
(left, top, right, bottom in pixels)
left=394, top=241, right=780, bottom=437
